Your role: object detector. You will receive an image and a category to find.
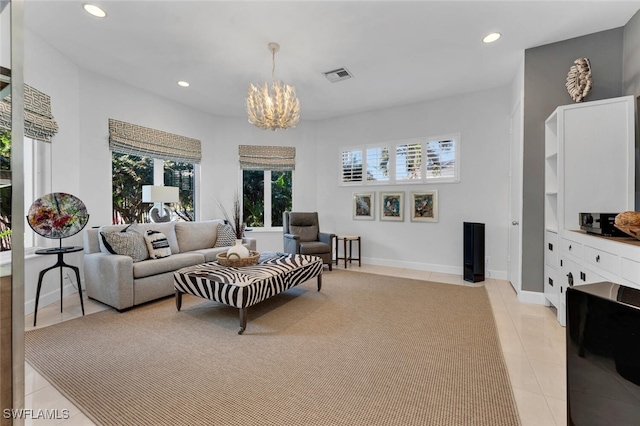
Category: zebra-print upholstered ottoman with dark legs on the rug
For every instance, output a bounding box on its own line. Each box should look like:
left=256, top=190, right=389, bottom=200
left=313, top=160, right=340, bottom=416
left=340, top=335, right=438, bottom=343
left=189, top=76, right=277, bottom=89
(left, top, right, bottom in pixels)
left=173, top=253, right=322, bottom=334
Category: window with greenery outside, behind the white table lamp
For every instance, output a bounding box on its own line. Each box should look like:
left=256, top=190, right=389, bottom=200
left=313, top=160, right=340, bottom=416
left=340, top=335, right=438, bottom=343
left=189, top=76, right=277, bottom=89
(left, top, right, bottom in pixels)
left=112, top=152, right=195, bottom=224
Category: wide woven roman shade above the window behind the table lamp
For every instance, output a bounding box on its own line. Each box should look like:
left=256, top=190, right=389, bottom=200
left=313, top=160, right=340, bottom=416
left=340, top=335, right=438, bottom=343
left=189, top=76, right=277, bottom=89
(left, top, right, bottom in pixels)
left=109, top=118, right=202, bottom=163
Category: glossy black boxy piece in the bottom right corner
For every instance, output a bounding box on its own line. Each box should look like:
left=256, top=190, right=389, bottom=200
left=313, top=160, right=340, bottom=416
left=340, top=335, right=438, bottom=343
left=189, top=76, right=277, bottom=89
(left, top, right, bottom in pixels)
left=566, top=282, right=640, bottom=426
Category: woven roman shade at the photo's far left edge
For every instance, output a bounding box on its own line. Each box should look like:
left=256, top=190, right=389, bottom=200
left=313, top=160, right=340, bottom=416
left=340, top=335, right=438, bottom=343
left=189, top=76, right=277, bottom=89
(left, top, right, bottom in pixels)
left=0, top=84, right=58, bottom=142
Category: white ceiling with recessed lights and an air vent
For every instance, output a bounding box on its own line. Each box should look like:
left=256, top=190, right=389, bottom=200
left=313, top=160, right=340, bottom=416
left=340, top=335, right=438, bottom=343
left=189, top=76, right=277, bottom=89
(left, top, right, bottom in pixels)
left=24, top=0, right=640, bottom=120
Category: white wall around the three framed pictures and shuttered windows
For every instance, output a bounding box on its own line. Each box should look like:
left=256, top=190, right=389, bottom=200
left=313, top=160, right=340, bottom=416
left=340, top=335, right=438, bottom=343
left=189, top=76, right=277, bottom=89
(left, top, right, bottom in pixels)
left=317, top=87, right=511, bottom=279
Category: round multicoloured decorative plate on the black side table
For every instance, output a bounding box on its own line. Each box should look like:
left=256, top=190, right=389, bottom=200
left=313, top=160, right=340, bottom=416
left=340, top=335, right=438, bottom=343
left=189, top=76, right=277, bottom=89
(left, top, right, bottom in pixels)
left=27, top=192, right=89, bottom=239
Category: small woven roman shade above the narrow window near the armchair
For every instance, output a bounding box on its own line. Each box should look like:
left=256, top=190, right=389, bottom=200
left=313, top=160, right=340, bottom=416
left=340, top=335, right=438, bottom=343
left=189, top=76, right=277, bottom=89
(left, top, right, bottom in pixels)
left=238, top=145, right=296, bottom=171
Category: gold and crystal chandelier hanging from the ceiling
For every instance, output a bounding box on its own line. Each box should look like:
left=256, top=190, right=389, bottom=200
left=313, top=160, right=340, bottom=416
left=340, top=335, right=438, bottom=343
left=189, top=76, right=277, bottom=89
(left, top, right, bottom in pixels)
left=247, top=42, right=300, bottom=130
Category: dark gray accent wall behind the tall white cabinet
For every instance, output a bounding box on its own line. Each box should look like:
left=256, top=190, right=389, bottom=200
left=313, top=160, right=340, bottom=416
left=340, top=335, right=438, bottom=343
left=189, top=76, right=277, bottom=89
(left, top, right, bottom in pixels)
left=521, top=27, right=624, bottom=292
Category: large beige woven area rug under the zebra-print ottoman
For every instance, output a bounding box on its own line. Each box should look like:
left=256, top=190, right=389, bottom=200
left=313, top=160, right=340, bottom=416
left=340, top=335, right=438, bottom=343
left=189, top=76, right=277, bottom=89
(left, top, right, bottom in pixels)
left=25, top=270, right=520, bottom=426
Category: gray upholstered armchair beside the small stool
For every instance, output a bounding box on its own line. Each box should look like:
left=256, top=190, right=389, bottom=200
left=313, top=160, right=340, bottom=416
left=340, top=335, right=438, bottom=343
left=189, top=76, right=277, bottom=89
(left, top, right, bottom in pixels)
left=282, top=212, right=335, bottom=271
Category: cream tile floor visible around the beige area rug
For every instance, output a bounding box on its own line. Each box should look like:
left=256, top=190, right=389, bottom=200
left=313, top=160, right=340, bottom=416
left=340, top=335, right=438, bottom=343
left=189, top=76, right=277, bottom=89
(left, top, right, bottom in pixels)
left=25, top=265, right=566, bottom=426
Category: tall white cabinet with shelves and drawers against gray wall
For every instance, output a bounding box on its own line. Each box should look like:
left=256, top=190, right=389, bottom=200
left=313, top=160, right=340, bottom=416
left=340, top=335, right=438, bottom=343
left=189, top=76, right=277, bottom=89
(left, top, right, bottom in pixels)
left=544, top=96, right=640, bottom=324
